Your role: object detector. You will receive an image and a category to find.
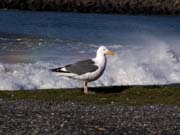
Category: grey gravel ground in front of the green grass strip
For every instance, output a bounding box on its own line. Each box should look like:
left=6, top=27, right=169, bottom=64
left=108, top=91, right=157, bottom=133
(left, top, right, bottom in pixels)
left=0, top=100, right=180, bottom=135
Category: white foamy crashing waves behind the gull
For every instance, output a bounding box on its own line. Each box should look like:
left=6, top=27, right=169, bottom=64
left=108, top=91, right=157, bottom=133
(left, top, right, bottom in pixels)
left=0, top=40, right=180, bottom=90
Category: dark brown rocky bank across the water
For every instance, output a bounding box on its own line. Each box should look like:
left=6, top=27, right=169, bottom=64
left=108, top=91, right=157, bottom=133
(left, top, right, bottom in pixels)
left=0, top=0, right=180, bottom=15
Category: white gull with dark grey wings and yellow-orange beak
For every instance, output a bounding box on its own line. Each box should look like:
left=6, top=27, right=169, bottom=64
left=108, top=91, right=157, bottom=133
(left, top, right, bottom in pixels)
left=50, top=46, right=115, bottom=94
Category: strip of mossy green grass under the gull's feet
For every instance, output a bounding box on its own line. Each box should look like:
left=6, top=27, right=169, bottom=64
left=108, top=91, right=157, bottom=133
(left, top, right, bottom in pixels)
left=0, top=86, right=180, bottom=106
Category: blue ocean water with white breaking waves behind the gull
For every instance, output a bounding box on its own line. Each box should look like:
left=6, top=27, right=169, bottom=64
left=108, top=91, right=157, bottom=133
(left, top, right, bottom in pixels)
left=0, top=10, right=180, bottom=90
